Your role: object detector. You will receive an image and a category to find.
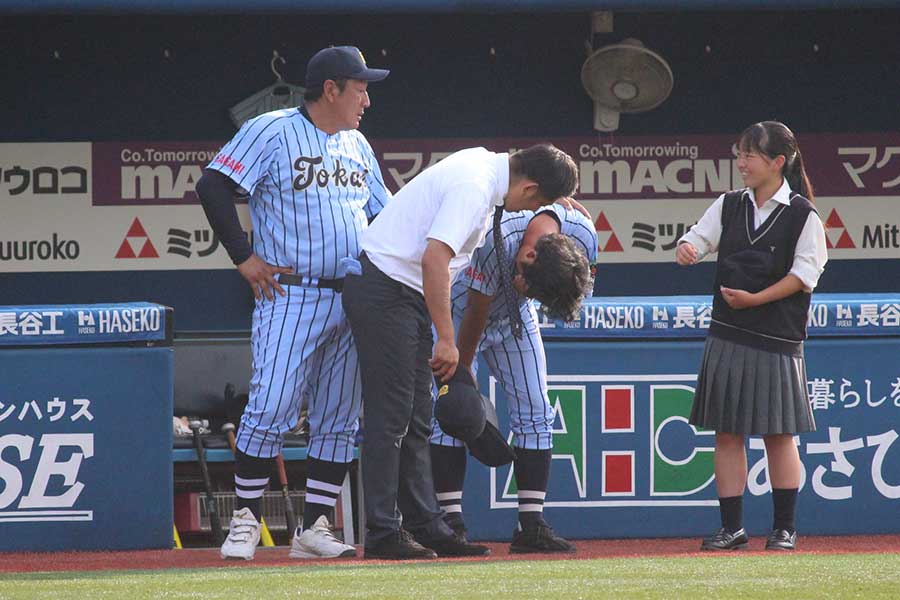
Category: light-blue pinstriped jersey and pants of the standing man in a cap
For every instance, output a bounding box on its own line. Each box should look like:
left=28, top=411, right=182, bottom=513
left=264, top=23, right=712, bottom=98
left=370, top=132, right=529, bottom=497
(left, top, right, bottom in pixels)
left=209, top=108, right=390, bottom=463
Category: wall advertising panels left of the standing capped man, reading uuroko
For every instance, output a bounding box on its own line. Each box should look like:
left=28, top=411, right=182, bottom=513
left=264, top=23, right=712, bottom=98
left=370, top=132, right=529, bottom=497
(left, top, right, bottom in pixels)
left=0, top=143, right=250, bottom=273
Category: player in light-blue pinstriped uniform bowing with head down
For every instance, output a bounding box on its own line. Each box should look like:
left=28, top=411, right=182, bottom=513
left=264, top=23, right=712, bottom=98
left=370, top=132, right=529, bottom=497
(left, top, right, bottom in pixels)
left=431, top=204, right=598, bottom=553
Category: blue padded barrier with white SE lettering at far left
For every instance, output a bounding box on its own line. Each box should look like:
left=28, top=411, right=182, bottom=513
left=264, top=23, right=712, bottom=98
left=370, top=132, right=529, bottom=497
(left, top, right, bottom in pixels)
left=0, top=304, right=173, bottom=551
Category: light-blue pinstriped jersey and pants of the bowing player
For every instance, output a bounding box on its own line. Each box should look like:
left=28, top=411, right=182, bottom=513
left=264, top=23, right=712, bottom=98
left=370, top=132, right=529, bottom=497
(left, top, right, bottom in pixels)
left=431, top=204, right=598, bottom=450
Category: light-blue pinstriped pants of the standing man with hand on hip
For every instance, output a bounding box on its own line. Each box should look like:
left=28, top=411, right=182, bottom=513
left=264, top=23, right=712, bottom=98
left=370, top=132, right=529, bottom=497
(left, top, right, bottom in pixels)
left=237, top=286, right=361, bottom=463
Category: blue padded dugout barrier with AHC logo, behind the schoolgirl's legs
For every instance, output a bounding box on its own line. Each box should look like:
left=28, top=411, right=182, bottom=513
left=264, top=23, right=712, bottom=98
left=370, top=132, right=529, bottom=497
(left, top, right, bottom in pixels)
left=463, top=296, right=900, bottom=540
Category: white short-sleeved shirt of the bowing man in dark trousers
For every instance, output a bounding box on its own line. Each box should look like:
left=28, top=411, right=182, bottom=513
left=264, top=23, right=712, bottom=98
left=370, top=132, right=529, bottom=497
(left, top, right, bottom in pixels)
left=362, top=148, right=509, bottom=293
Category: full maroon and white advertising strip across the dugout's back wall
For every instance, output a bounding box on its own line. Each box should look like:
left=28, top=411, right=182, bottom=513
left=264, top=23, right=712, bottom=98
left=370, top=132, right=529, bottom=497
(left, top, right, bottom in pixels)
left=0, top=133, right=900, bottom=272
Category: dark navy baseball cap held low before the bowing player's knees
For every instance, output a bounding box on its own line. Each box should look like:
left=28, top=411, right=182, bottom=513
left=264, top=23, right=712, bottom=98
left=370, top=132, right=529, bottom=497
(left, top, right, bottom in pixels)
left=434, top=368, right=516, bottom=467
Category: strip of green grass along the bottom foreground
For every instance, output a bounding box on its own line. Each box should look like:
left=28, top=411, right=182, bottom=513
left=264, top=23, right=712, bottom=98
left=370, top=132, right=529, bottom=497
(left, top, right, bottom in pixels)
left=0, top=554, right=900, bottom=600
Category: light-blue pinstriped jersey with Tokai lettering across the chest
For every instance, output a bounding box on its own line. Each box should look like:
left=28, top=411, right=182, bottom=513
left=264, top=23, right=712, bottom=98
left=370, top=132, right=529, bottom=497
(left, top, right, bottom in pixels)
left=208, top=108, right=390, bottom=279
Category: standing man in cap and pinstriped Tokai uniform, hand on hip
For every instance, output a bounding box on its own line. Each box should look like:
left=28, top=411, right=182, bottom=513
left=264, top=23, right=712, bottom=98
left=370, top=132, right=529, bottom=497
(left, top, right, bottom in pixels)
left=197, top=46, right=390, bottom=560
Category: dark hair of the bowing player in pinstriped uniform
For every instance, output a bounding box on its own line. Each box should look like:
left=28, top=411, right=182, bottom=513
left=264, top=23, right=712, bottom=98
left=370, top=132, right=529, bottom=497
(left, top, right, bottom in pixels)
left=522, top=233, right=594, bottom=321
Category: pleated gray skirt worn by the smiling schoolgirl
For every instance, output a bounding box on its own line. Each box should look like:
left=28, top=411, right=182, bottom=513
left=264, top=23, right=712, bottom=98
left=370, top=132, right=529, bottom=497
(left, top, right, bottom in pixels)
left=690, top=336, right=816, bottom=435
